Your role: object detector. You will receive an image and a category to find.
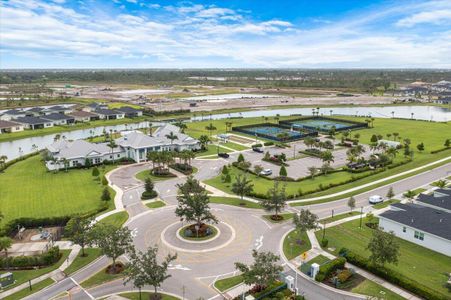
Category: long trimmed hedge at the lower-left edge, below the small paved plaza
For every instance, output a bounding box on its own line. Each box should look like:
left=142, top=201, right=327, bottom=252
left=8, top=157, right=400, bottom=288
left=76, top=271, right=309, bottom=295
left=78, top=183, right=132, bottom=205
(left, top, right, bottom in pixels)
left=0, top=246, right=62, bottom=270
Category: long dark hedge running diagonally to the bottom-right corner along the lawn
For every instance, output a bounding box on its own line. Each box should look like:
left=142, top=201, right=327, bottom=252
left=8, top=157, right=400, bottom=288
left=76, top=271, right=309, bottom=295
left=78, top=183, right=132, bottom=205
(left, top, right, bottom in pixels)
left=339, top=248, right=449, bottom=300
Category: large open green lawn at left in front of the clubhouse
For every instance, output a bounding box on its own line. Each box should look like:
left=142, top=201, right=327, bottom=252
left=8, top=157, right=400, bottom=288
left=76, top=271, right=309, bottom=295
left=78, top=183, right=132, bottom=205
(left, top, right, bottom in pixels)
left=0, top=155, right=114, bottom=224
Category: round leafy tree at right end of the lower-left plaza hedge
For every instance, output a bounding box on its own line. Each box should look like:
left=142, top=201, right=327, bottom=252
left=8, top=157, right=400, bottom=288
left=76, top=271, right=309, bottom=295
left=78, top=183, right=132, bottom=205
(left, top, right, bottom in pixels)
left=64, top=215, right=93, bottom=256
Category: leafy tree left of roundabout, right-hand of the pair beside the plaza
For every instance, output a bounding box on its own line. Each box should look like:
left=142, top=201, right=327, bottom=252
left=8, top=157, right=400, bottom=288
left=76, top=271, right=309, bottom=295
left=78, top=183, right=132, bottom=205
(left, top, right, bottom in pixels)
left=92, top=223, right=132, bottom=273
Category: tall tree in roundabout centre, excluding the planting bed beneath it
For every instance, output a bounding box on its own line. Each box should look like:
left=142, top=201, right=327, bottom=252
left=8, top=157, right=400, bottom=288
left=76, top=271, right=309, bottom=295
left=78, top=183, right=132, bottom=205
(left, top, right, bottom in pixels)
left=175, top=176, right=218, bottom=228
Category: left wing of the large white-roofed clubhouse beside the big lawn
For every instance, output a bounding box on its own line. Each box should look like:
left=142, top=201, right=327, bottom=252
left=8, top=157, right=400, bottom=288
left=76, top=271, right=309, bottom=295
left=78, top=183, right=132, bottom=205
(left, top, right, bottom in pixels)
left=46, top=140, right=125, bottom=170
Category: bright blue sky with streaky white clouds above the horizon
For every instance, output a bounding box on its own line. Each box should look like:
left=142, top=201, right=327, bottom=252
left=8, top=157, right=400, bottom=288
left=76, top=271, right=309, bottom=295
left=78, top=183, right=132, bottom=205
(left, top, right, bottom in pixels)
left=0, top=0, right=451, bottom=69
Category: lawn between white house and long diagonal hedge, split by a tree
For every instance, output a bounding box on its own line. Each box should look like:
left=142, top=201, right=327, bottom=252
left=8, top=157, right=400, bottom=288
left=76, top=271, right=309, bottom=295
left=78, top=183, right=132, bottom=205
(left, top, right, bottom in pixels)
left=316, top=220, right=451, bottom=297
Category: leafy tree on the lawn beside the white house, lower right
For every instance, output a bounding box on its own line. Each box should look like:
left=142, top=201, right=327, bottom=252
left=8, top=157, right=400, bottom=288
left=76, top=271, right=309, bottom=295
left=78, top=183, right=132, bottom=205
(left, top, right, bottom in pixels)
left=366, top=229, right=399, bottom=266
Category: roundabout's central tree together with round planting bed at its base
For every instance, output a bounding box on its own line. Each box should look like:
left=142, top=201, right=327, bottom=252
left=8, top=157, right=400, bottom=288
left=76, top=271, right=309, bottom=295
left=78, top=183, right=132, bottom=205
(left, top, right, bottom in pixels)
left=175, top=176, right=218, bottom=238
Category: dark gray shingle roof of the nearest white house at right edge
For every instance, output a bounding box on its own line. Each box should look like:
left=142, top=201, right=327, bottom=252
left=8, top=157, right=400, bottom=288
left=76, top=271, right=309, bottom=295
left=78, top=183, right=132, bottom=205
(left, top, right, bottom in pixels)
left=380, top=203, right=451, bottom=240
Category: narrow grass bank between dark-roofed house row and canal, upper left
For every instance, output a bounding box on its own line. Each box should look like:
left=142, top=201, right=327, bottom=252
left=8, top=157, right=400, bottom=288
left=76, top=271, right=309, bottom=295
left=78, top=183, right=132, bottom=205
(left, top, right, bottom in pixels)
left=0, top=117, right=146, bottom=142
